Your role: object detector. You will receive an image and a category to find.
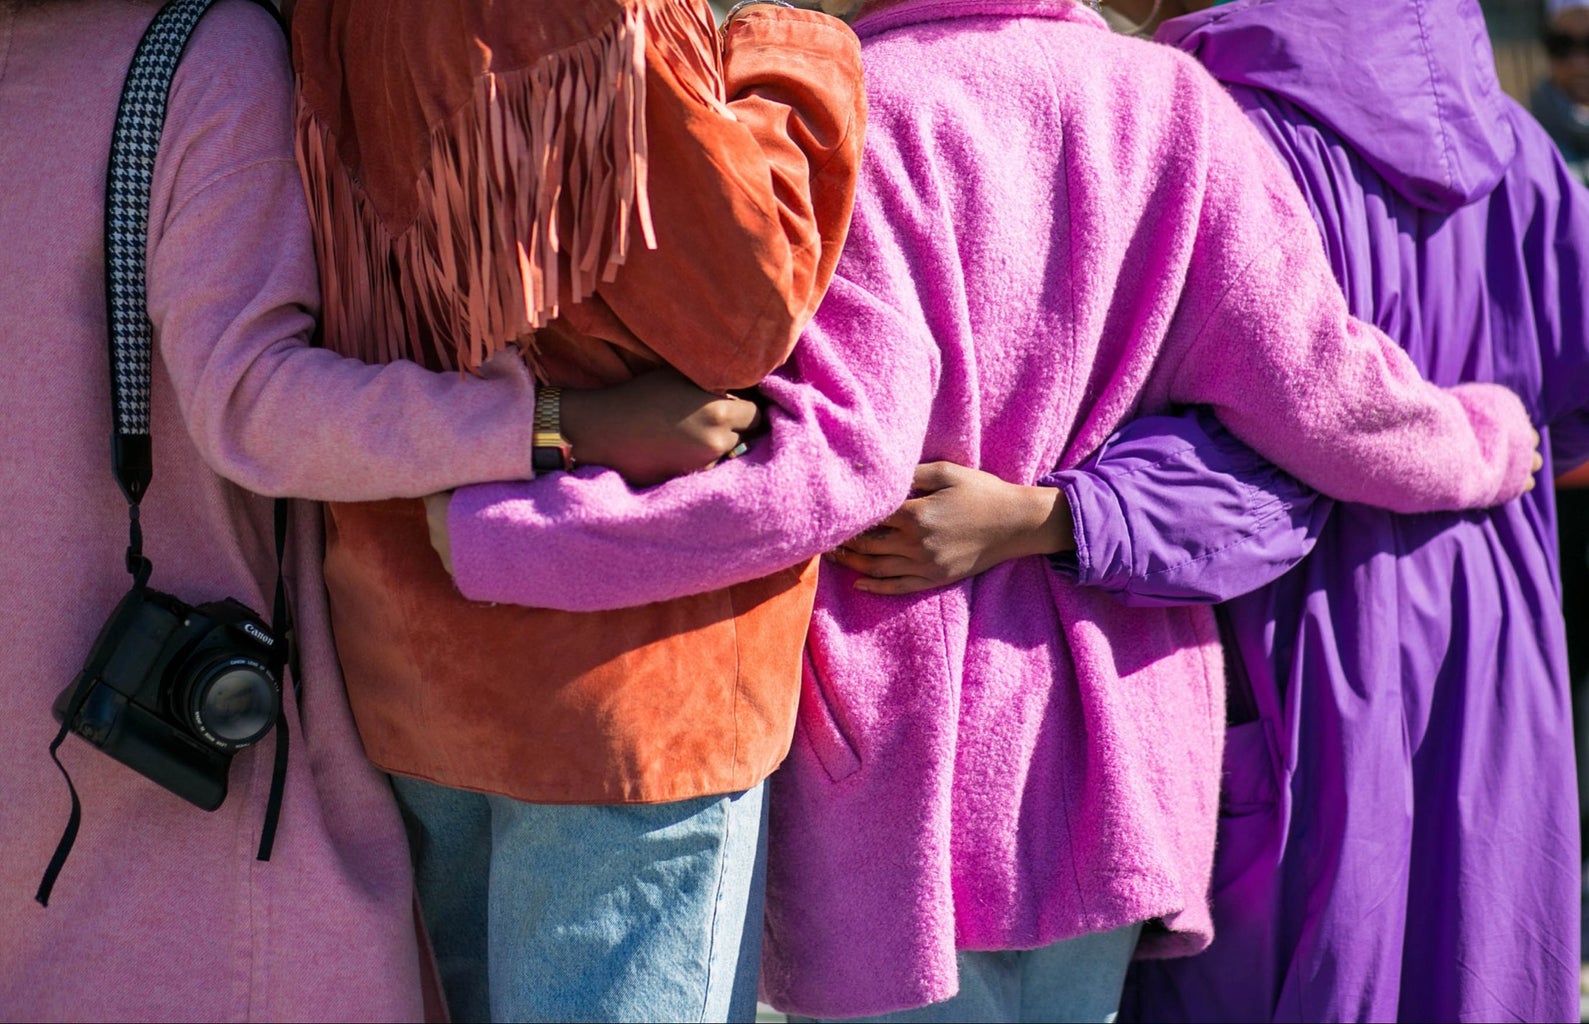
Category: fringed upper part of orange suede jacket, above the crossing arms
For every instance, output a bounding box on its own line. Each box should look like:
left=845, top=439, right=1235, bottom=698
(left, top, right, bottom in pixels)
left=299, top=0, right=864, bottom=390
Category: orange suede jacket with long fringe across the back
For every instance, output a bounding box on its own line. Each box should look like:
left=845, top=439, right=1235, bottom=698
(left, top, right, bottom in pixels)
left=292, top=0, right=864, bottom=803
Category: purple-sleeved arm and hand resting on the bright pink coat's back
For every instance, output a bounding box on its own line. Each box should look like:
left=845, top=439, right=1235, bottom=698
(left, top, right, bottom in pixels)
left=834, top=410, right=1333, bottom=606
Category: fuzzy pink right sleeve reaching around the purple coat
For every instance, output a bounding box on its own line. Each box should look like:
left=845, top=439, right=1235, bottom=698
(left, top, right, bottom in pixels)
left=1155, top=77, right=1533, bottom=512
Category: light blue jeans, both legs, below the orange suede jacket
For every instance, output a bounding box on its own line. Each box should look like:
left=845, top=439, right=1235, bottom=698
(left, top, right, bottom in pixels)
left=392, top=776, right=766, bottom=1022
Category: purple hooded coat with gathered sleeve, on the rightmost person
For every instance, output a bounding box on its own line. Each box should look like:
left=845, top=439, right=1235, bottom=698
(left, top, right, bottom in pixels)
left=1052, top=0, right=1589, bottom=1021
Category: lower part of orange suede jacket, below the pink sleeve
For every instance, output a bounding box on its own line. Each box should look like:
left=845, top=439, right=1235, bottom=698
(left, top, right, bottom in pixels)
left=326, top=501, right=817, bottom=803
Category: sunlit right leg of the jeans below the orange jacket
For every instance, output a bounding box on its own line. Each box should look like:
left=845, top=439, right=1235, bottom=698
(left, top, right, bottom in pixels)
left=489, top=785, right=764, bottom=1021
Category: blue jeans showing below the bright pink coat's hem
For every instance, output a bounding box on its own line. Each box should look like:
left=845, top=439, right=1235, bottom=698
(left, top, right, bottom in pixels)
left=790, top=924, right=1142, bottom=1024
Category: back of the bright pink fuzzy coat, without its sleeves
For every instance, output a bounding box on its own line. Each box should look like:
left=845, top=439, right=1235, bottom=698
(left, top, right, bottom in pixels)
left=763, top=8, right=1222, bottom=1016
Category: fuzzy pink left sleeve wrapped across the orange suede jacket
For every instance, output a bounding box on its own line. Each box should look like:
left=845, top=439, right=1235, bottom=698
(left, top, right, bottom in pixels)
left=445, top=268, right=938, bottom=611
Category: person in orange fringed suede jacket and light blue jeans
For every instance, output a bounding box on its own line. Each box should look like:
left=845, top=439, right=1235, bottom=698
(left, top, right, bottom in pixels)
left=292, top=0, right=864, bottom=1021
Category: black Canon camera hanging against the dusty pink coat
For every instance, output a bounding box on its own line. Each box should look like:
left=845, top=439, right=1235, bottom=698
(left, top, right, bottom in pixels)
left=54, top=587, right=283, bottom=811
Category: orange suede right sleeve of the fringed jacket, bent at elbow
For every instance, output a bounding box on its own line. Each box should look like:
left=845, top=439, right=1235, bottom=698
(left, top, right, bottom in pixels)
left=552, top=5, right=866, bottom=391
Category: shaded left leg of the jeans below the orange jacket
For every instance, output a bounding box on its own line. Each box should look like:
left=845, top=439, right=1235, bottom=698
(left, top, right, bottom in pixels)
left=392, top=776, right=491, bottom=1024
